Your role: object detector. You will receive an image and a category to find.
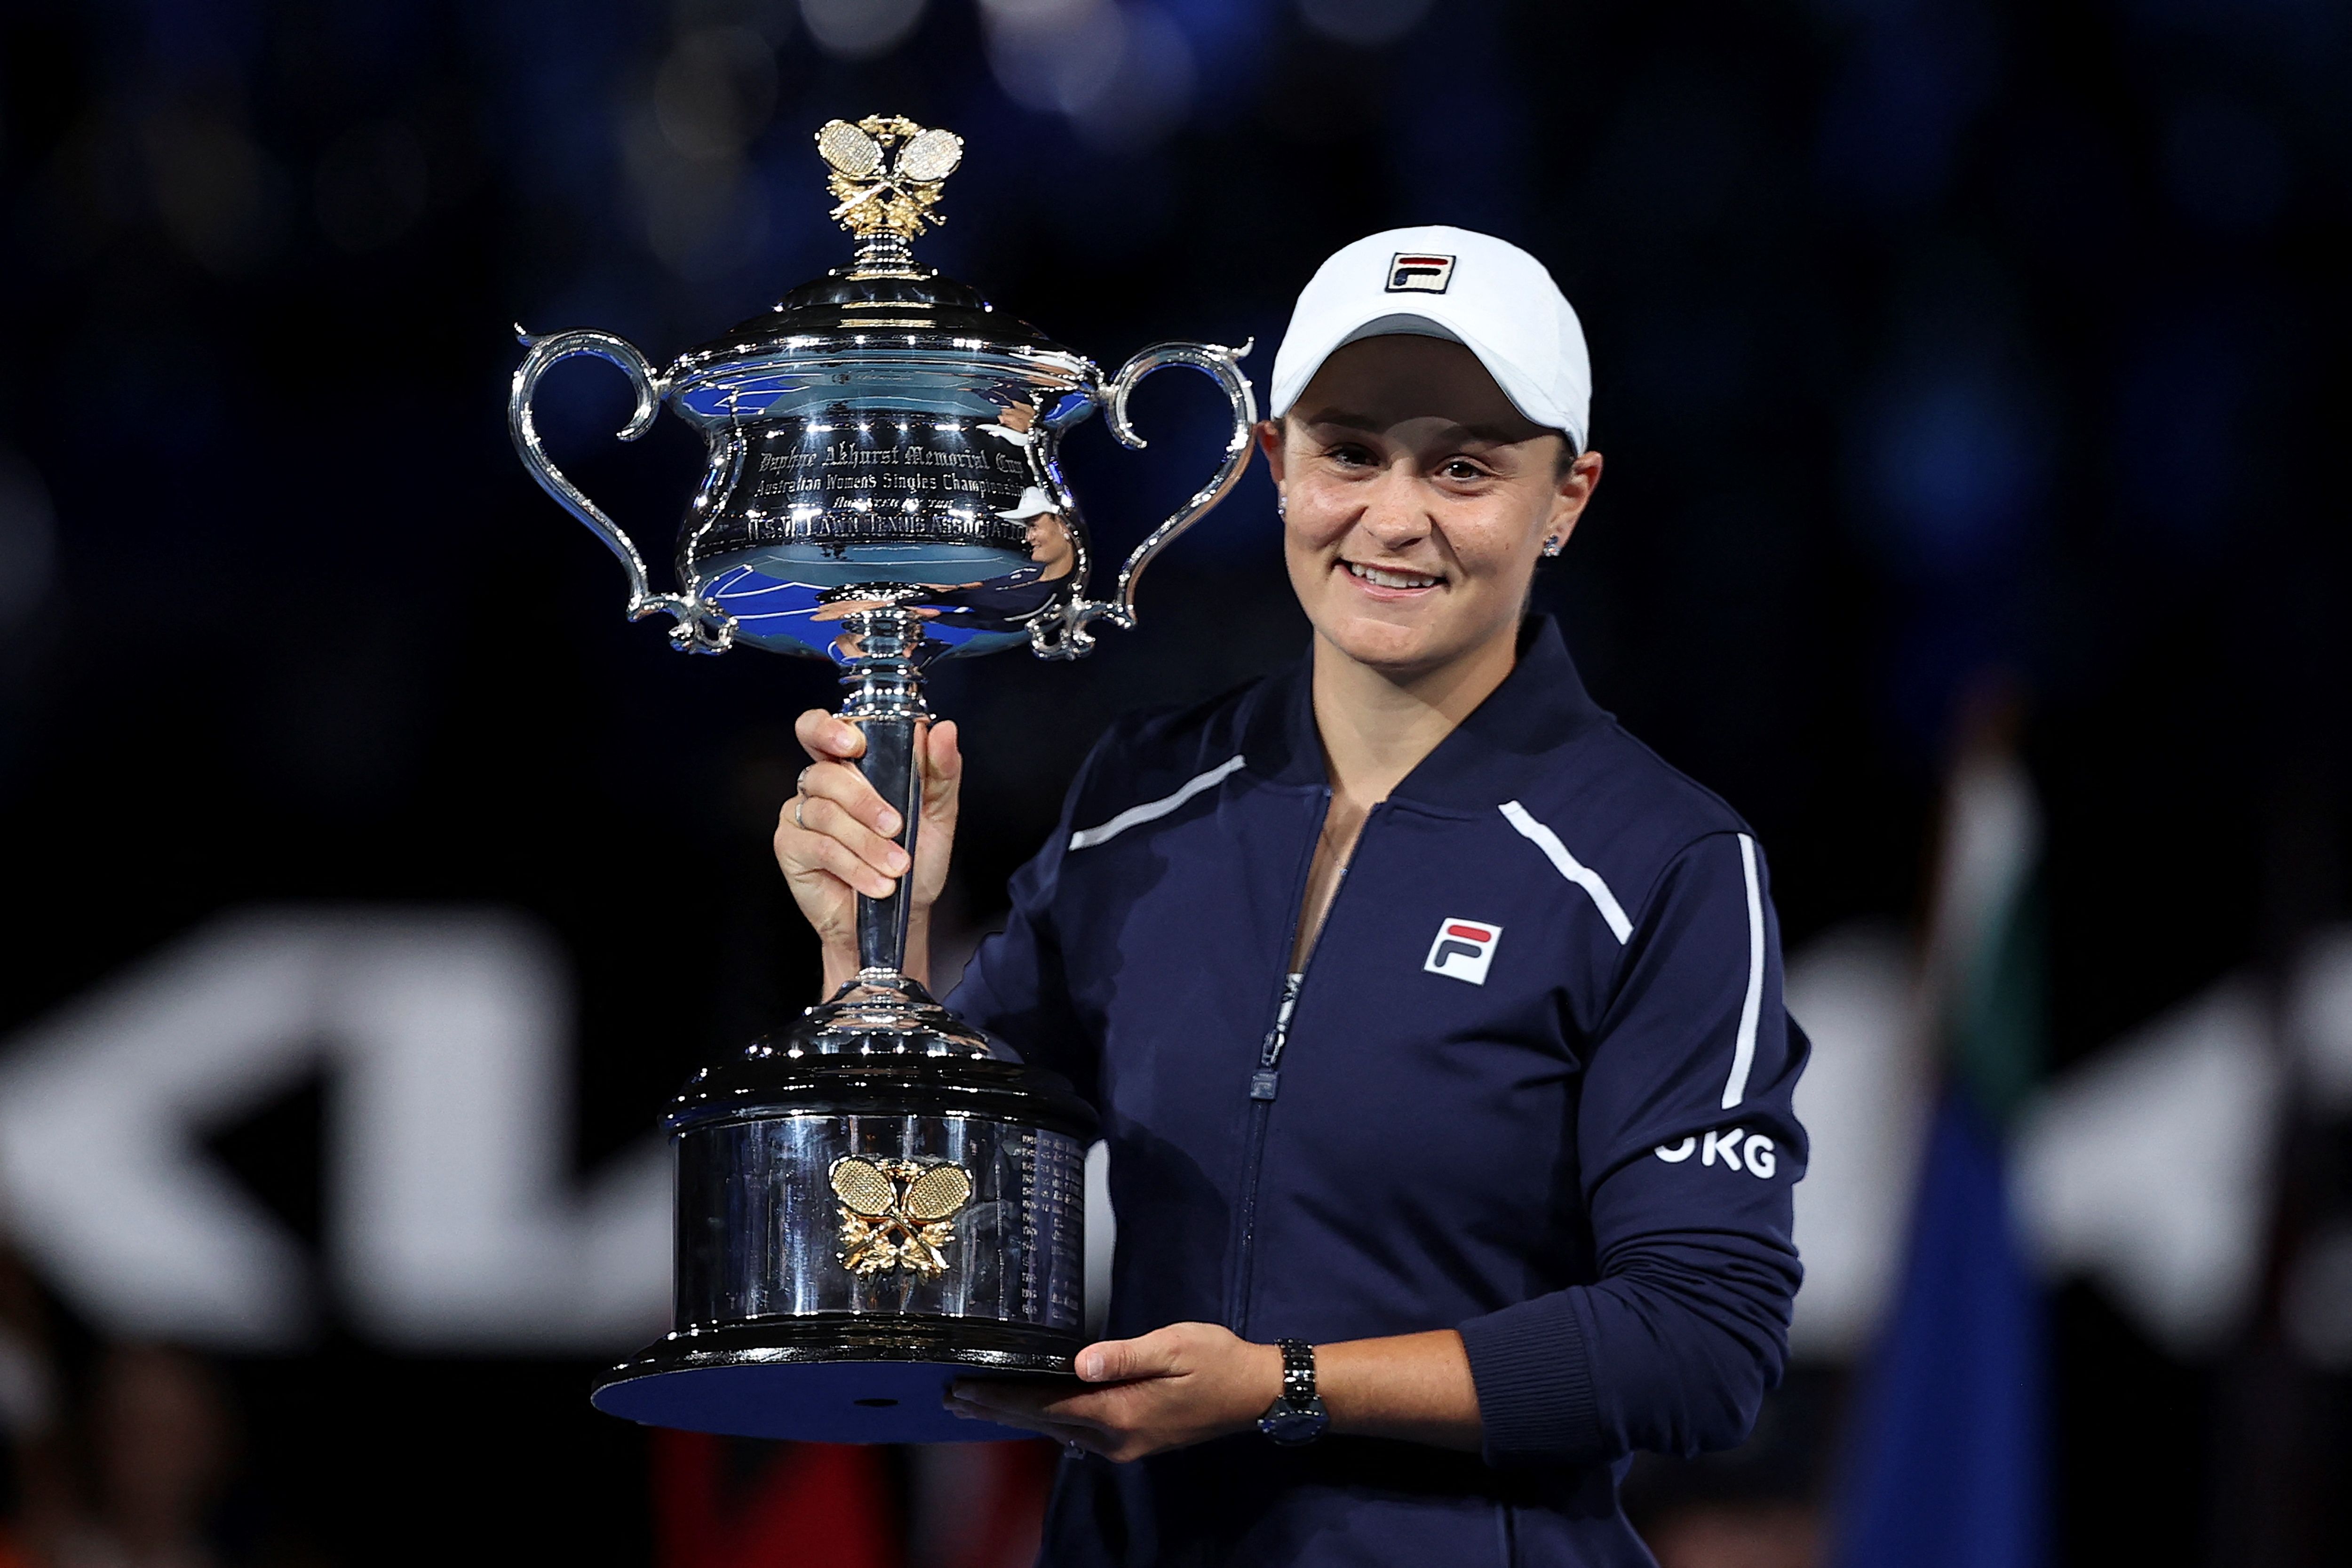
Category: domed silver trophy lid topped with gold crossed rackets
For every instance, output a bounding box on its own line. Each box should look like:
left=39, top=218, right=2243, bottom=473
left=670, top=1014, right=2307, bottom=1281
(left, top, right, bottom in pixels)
left=670, top=115, right=1091, bottom=379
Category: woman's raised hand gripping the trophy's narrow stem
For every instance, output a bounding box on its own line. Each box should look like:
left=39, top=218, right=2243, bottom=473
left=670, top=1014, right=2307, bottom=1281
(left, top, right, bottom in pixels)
left=776, top=708, right=964, bottom=995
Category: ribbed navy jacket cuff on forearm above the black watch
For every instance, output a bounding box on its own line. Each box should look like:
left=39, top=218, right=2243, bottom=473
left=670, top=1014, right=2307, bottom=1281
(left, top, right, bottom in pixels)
left=1458, top=1290, right=1604, bottom=1465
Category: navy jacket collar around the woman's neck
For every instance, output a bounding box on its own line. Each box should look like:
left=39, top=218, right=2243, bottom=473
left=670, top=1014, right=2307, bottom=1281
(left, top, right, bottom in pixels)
left=1242, top=616, right=1609, bottom=811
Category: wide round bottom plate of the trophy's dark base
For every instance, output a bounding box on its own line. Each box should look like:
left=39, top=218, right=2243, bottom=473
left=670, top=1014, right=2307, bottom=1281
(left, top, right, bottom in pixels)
left=590, top=1314, right=1082, bottom=1443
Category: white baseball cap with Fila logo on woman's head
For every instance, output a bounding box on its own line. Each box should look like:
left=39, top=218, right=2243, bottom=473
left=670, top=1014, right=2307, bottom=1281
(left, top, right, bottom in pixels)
left=1270, top=223, right=1592, bottom=451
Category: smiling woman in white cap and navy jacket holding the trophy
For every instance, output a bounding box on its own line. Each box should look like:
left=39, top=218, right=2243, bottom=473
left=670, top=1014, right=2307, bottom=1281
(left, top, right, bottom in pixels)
left=776, top=228, right=1806, bottom=1566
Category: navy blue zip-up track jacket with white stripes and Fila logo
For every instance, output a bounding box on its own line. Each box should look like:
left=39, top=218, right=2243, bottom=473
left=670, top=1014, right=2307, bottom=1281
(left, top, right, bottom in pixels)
left=955, top=621, right=1806, bottom=1568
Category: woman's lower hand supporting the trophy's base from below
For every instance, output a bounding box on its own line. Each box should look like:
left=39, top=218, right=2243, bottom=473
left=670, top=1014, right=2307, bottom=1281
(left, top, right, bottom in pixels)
left=948, top=1323, right=1282, bottom=1465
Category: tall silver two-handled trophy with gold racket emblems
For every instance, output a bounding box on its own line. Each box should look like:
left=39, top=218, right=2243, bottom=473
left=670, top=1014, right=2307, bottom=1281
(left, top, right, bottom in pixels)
left=508, top=118, right=1258, bottom=1441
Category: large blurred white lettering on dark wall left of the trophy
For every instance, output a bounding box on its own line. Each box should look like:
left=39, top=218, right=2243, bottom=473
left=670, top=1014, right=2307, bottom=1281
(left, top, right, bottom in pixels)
left=0, top=910, right=670, bottom=1352
